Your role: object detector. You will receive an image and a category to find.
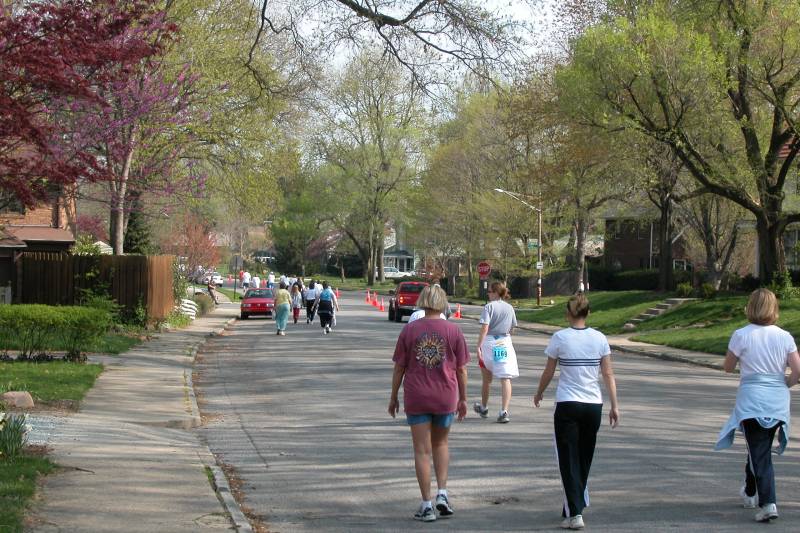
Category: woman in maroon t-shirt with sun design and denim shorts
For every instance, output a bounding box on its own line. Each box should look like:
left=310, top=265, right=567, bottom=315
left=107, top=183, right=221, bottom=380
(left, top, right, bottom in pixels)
left=389, top=286, right=469, bottom=522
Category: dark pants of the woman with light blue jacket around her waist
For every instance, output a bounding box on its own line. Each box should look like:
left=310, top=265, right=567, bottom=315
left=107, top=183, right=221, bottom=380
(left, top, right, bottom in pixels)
left=742, top=418, right=781, bottom=505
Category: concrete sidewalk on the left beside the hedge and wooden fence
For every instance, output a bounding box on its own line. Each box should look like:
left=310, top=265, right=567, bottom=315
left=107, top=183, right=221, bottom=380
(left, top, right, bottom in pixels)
left=29, top=304, right=250, bottom=532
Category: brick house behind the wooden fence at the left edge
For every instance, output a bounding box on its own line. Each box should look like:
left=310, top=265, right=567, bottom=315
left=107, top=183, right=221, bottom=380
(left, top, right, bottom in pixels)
left=0, top=194, right=75, bottom=287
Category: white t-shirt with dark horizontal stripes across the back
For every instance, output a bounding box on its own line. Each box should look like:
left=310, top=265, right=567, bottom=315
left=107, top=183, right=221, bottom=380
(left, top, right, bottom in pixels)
left=544, top=328, right=611, bottom=403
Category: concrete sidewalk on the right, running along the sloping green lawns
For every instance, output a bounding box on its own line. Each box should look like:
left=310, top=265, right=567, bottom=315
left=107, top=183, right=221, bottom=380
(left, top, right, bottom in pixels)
left=454, top=304, right=724, bottom=370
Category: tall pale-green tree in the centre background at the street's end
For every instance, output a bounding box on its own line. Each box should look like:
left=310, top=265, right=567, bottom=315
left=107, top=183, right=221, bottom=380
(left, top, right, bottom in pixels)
left=317, top=53, right=422, bottom=284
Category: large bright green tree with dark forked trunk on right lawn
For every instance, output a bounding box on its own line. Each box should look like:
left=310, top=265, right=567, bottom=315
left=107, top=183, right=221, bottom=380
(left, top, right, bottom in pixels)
left=560, top=0, right=800, bottom=280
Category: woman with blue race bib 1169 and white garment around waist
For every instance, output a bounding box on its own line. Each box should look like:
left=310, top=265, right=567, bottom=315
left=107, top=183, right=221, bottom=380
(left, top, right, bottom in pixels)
left=473, top=281, right=519, bottom=424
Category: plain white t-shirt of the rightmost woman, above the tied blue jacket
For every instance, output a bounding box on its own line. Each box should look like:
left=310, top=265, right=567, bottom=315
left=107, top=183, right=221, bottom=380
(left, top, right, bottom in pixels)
left=728, top=324, right=797, bottom=376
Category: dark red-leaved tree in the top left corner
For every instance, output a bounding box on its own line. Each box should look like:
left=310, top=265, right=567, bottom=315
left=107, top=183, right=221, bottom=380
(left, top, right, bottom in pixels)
left=0, top=0, right=166, bottom=207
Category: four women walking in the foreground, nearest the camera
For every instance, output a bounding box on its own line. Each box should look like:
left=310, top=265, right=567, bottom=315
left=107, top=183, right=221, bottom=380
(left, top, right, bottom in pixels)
left=388, top=282, right=800, bottom=530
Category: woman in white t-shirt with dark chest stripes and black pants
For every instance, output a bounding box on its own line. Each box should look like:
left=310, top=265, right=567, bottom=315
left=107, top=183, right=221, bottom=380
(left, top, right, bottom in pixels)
left=533, top=294, right=619, bottom=529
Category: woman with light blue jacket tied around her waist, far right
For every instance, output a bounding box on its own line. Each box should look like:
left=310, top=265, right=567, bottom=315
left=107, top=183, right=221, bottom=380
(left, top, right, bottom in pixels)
left=716, top=289, right=800, bottom=522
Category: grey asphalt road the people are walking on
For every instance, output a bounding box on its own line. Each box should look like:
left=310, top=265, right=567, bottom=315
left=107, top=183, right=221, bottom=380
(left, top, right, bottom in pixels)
left=196, top=293, right=800, bottom=532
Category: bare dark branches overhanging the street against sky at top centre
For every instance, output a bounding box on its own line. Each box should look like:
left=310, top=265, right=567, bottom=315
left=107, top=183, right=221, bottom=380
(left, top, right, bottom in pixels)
left=247, top=0, right=525, bottom=85
